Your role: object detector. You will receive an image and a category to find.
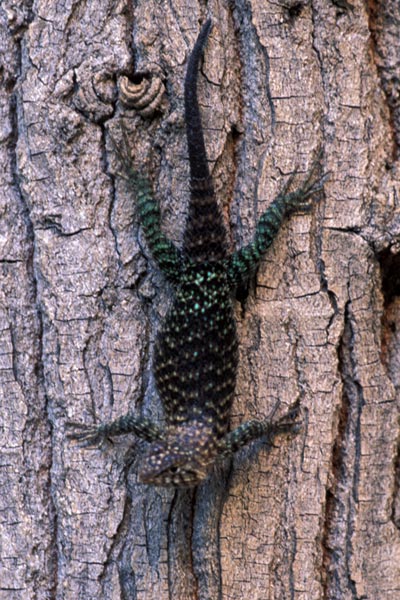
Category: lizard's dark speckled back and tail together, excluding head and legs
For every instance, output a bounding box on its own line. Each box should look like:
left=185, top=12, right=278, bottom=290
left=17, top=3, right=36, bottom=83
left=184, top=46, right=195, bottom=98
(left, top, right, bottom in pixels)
left=153, top=21, right=237, bottom=440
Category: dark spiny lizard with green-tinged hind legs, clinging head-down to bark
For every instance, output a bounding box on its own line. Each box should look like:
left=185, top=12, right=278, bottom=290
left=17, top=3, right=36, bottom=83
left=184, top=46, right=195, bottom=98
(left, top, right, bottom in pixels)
left=68, top=19, right=325, bottom=487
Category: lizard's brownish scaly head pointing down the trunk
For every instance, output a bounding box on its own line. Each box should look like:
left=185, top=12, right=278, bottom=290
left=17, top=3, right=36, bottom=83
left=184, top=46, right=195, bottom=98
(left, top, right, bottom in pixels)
left=139, top=421, right=217, bottom=487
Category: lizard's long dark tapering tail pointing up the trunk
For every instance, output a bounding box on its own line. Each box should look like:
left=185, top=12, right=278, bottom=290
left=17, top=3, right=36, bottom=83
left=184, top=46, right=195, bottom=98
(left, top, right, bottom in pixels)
left=183, top=19, right=227, bottom=263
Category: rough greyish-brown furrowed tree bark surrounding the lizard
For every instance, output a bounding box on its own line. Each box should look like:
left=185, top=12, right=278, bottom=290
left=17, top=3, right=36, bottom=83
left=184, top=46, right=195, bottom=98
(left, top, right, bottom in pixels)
left=0, top=0, right=400, bottom=600
